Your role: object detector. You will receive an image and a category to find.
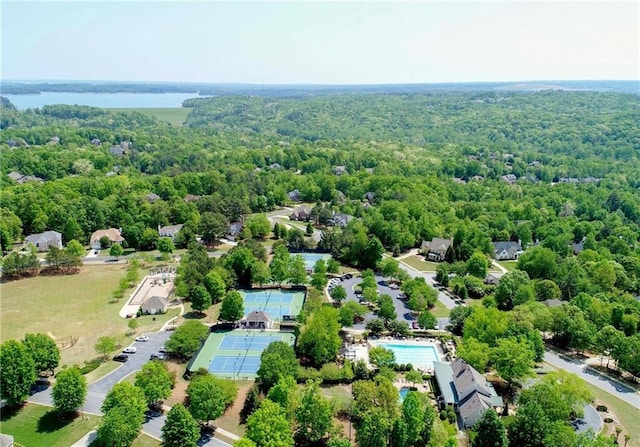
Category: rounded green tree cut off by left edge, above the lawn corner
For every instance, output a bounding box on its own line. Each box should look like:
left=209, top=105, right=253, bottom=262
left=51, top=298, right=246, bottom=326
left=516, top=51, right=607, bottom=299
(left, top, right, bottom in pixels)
left=0, top=340, right=36, bottom=406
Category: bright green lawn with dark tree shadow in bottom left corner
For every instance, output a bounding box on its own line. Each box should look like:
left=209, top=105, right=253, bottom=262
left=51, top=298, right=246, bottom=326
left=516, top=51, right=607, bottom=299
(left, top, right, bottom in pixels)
left=0, top=404, right=99, bottom=447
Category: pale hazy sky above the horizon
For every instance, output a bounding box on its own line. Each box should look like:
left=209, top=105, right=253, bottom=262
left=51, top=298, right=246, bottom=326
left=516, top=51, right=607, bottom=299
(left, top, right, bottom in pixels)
left=0, top=0, right=640, bottom=84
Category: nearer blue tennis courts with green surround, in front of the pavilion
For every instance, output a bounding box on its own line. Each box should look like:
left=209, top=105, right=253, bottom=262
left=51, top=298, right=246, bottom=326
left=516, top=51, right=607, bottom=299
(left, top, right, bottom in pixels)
left=187, top=330, right=295, bottom=380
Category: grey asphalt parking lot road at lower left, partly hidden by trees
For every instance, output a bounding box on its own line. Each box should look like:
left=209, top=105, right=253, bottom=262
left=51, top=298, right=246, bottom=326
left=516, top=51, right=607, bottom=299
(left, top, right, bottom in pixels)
left=27, top=331, right=231, bottom=447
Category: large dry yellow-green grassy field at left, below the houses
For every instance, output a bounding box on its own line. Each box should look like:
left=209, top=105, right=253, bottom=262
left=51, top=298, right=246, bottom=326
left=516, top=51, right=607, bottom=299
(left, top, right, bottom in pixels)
left=0, top=264, right=178, bottom=366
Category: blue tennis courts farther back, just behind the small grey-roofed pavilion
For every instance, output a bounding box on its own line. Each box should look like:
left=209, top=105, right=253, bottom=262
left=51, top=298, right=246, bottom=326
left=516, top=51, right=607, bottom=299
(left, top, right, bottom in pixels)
left=240, top=289, right=305, bottom=321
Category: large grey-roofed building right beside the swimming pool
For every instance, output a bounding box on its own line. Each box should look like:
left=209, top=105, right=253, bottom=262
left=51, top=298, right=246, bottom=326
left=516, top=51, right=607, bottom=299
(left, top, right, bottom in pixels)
left=433, top=358, right=503, bottom=429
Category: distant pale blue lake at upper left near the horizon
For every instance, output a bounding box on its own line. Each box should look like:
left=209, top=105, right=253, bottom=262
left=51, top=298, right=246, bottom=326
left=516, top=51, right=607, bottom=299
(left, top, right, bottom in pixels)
left=3, top=92, right=198, bottom=110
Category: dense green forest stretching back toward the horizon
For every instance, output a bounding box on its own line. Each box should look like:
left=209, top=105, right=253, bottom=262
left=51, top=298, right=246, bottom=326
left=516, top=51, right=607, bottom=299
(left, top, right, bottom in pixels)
left=0, top=91, right=640, bottom=445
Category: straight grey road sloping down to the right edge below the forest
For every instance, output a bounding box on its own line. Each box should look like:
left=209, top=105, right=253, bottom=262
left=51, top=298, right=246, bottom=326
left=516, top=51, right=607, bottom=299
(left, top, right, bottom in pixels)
left=544, top=351, right=640, bottom=408
